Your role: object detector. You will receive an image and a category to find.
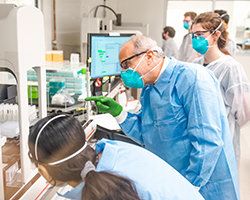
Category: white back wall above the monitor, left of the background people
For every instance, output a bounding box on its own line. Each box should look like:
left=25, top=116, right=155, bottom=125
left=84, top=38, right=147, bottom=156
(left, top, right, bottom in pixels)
left=42, top=0, right=165, bottom=59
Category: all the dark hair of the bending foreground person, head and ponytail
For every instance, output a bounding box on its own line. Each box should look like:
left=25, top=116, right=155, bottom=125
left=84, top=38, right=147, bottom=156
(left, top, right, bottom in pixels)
left=28, top=114, right=139, bottom=200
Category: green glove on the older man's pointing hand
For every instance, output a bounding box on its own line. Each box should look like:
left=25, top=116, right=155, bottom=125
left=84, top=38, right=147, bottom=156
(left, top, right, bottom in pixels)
left=85, top=96, right=123, bottom=117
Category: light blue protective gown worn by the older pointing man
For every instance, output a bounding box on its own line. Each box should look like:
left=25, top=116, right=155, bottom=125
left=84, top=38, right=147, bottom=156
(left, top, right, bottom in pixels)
left=120, top=58, right=240, bottom=200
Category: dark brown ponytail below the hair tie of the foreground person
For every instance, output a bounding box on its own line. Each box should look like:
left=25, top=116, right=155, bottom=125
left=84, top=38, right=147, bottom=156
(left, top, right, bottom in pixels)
left=82, top=171, right=140, bottom=200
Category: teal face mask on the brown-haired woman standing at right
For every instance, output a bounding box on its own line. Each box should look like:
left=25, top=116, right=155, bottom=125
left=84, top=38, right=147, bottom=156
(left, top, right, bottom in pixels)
left=191, top=22, right=222, bottom=55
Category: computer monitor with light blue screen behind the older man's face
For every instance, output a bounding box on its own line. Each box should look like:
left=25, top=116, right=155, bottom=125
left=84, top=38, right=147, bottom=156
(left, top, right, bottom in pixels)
left=88, top=33, right=133, bottom=78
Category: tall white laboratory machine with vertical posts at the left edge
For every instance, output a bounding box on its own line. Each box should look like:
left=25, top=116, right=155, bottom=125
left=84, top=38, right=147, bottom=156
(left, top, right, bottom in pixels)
left=0, top=4, right=47, bottom=199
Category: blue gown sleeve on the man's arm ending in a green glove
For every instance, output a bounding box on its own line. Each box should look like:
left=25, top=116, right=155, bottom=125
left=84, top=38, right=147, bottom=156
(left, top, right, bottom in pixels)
left=120, top=109, right=144, bottom=145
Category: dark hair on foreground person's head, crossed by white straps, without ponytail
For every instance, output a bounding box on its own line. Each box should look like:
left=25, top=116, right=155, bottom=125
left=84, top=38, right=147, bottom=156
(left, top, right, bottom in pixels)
left=28, top=114, right=96, bottom=182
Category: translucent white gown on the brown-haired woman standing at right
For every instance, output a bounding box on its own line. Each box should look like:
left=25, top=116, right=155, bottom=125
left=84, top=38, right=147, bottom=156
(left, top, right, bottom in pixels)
left=193, top=55, right=250, bottom=169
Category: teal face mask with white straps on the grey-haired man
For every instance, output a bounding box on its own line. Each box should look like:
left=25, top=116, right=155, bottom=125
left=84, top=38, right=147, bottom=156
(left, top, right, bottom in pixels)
left=121, top=49, right=161, bottom=88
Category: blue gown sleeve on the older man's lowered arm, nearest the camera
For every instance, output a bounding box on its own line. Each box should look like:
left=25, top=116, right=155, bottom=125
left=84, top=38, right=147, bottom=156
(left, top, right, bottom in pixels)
left=179, top=76, right=226, bottom=187
